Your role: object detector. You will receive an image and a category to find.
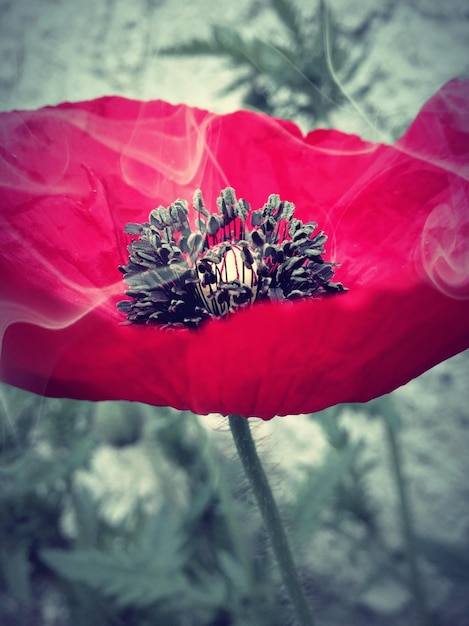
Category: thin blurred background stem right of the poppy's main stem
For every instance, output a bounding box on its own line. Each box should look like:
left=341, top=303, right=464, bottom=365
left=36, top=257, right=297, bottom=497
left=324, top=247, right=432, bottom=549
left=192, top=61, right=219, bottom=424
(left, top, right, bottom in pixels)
left=384, top=419, right=434, bottom=626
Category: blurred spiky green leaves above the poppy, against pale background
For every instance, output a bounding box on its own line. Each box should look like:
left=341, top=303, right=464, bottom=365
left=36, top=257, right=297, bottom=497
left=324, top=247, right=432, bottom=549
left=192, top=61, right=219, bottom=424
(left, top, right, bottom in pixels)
left=158, top=0, right=352, bottom=126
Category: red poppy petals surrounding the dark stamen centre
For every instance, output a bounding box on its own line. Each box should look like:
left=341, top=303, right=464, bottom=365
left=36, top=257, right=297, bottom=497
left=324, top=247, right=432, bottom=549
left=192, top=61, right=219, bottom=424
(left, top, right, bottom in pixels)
left=0, top=80, right=469, bottom=419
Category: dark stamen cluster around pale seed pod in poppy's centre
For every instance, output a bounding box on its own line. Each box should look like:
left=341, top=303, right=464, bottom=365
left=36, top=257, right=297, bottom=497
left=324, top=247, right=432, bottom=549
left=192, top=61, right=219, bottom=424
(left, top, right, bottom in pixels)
left=117, top=187, right=345, bottom=327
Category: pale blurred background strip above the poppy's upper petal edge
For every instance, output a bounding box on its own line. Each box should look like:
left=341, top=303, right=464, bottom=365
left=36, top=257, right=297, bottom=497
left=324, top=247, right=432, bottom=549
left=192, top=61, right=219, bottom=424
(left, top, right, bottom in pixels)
left=0, top=0, right=469, bottom=136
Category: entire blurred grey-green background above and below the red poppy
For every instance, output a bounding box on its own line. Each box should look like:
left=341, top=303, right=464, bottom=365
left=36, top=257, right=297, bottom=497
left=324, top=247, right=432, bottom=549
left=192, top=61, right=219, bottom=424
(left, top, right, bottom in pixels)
left=0, top=0, right=469, bottom=626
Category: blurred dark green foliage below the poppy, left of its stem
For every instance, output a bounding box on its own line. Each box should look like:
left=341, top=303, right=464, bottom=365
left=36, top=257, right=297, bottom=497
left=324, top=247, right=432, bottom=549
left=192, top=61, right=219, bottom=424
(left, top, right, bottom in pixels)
left=0, top=387, right=288, bottom=626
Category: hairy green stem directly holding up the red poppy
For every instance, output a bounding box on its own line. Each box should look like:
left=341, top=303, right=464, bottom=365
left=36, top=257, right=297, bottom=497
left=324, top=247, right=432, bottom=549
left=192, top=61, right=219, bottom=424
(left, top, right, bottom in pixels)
left=228, top=415, right=314, bottom=626
